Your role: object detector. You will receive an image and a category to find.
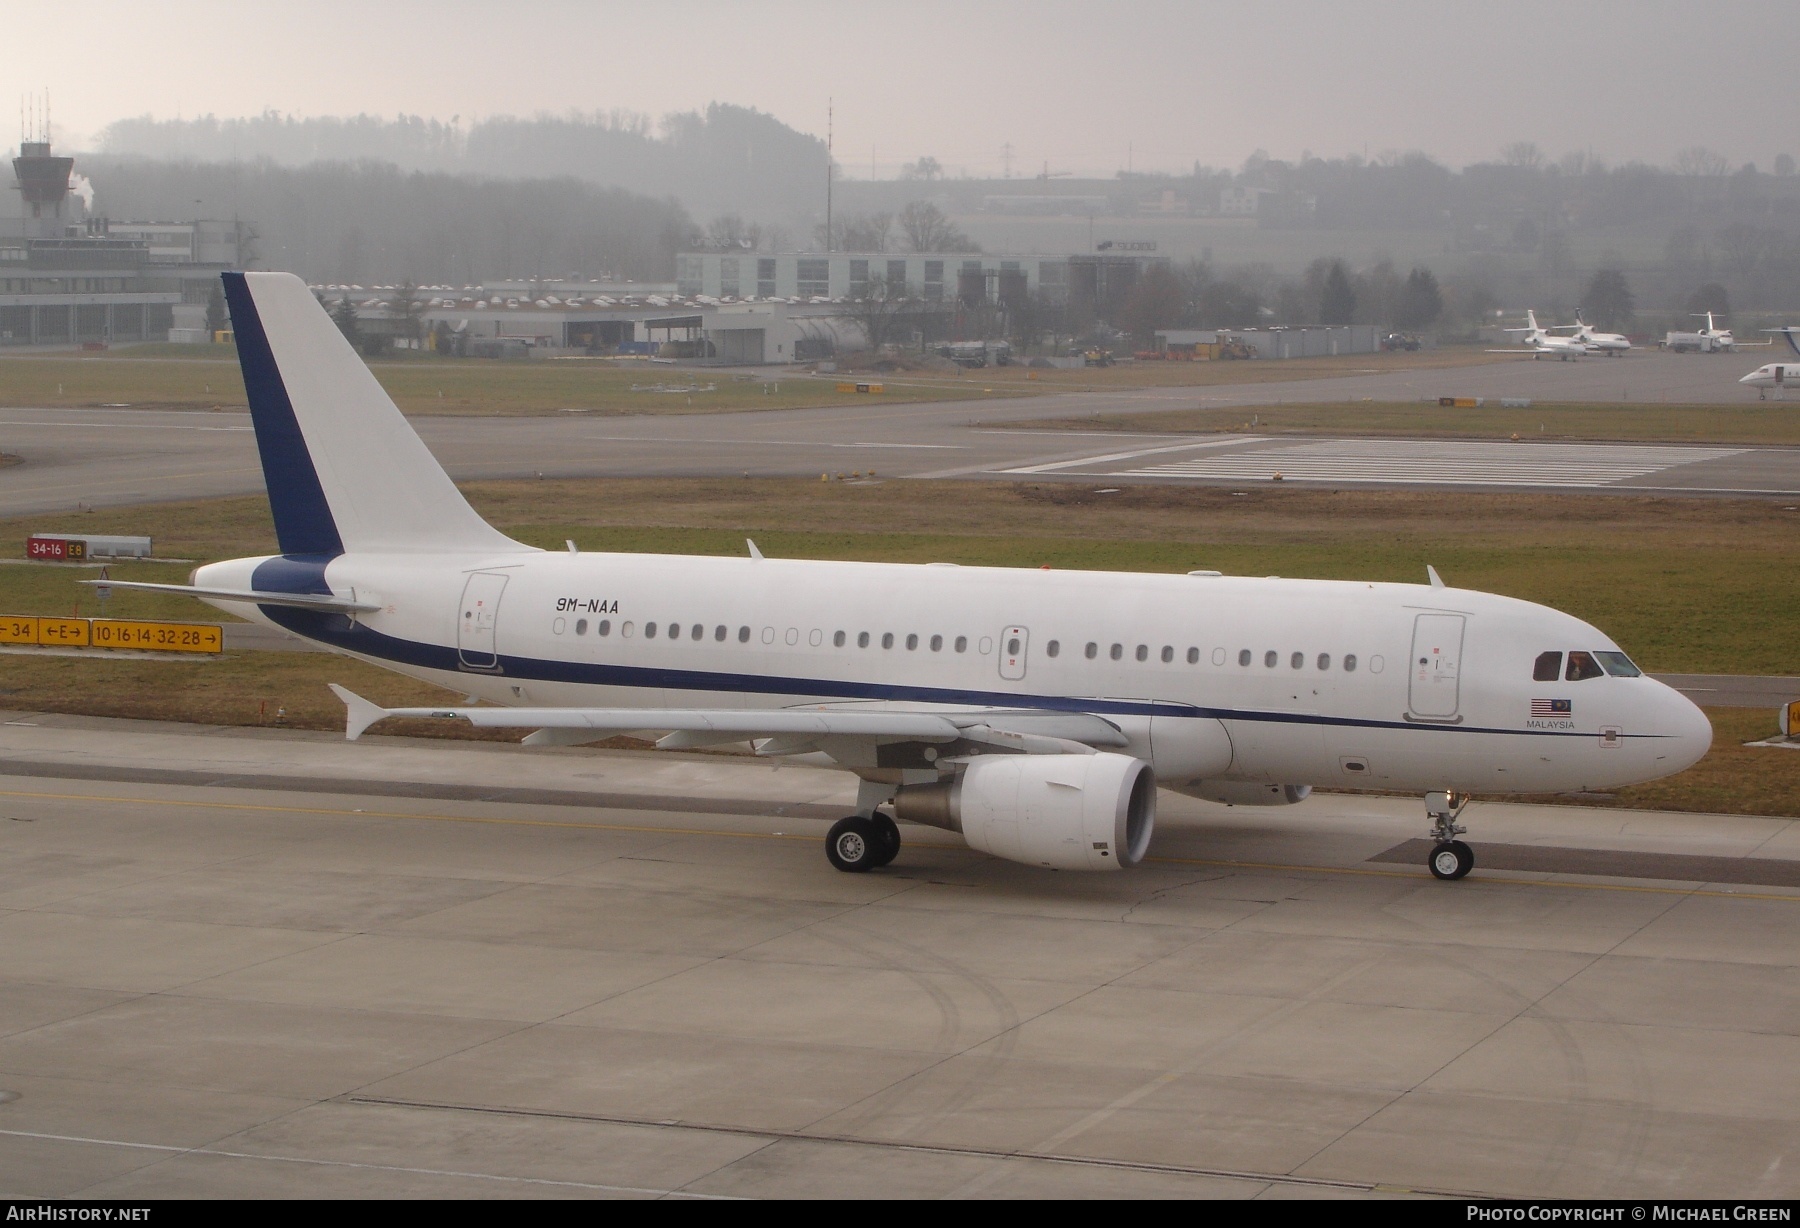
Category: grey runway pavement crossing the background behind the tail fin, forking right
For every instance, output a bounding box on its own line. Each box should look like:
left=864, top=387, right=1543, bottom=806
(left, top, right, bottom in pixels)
left=0, top=353, right=1800, bottom=517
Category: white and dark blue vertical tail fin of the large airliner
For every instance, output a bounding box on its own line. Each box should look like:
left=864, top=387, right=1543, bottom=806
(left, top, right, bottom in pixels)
left=223, top=274, right=529, bottom=555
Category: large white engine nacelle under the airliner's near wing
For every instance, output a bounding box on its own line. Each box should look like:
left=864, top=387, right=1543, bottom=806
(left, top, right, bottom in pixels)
left=895, top=754, right=1156, bottom=870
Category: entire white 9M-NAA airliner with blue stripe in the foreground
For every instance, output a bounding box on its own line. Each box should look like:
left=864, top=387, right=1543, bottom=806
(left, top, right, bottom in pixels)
left=108, top=272, right=1712, bottom=879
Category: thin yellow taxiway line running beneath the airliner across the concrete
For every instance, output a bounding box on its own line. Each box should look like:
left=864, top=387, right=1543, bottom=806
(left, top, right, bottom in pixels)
left=0, top=781, right=1800, bottom=904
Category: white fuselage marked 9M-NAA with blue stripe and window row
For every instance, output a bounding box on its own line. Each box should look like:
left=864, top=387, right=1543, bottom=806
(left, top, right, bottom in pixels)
left=194, top=553, right=1710, bottom=794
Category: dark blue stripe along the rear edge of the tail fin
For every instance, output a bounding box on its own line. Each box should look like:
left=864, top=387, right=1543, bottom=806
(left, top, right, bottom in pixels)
left=221, top=274, right=344, bottom=555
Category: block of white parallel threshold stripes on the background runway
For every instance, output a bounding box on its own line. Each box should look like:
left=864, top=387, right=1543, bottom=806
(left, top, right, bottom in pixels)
left=1108, top=439, right=1746, bottom=486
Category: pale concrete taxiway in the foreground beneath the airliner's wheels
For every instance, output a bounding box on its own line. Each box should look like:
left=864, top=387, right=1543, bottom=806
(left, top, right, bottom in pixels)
left=0, top=713, right=1800, bottom=1199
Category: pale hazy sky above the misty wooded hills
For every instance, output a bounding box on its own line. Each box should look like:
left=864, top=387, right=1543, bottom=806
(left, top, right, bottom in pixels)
left=0, top=0, right=1800, bottom=178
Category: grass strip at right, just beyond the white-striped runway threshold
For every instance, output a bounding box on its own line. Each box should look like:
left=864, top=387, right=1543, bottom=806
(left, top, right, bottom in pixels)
left=1004, top=402, right=1800, bottom=445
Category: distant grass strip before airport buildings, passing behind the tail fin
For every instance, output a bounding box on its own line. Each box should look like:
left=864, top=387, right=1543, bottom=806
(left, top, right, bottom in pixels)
left=0, top=346, right=1492, bottom=416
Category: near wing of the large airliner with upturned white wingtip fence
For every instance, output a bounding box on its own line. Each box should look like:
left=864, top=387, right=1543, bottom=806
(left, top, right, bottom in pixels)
left=331, top=682, right=1129, bottom=758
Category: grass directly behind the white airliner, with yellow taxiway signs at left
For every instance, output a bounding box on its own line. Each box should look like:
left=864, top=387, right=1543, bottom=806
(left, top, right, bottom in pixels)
left=0, top=479, right=1800, bottom=814
